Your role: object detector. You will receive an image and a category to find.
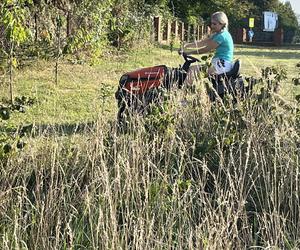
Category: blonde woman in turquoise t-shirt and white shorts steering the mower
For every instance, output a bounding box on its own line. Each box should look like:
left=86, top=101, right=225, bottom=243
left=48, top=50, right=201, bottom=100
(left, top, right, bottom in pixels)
left=183, top=12, right=234, bottom=75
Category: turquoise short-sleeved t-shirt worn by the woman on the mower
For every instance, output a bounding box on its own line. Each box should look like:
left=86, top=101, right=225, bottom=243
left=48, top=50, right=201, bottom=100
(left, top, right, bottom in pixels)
left=212, top=29, right=233, bottom=62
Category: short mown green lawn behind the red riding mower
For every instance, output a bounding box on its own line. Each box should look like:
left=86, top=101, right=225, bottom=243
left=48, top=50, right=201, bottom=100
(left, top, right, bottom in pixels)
left=0, top=46, right=300, bottom=127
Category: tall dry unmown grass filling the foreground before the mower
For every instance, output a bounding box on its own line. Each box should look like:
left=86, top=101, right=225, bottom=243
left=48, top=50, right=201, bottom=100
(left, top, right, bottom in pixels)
left=0, top=77, right=300, bottom=249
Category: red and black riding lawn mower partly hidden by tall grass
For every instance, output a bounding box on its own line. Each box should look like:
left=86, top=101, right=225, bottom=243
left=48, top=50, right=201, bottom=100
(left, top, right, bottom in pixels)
left=115, top=53, right=249, bottom=121
